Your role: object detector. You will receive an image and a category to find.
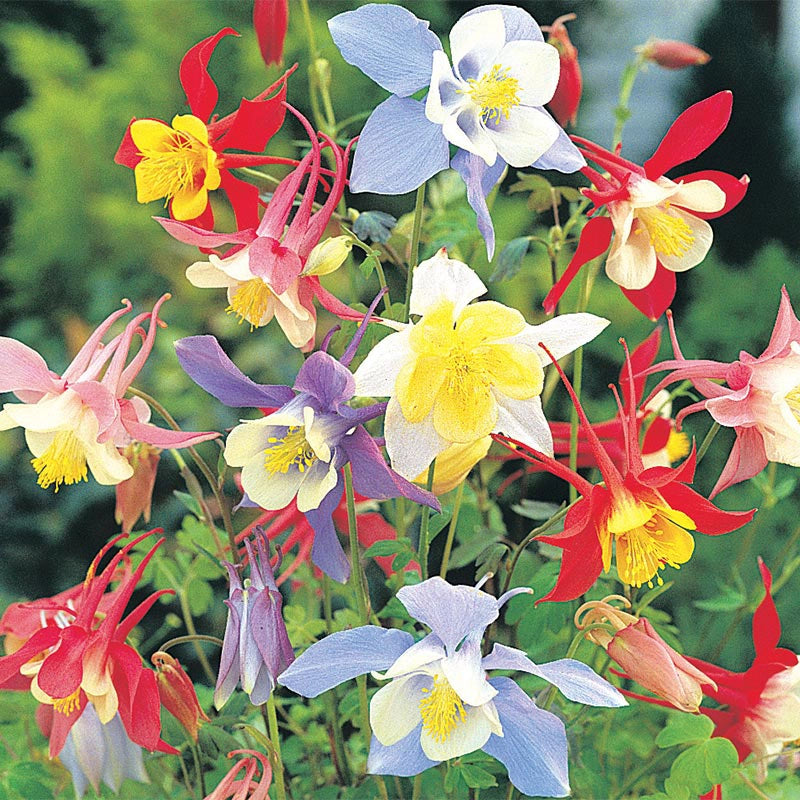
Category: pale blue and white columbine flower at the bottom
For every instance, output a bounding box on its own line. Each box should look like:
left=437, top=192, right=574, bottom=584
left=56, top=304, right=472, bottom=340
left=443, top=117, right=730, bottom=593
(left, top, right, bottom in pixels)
left=278, top=578, right=625, bottom=797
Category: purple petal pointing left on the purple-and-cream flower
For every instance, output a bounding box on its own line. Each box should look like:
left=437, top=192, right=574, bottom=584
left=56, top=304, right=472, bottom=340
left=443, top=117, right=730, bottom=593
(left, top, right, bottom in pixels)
left=175, top=336, right=294, bottom=408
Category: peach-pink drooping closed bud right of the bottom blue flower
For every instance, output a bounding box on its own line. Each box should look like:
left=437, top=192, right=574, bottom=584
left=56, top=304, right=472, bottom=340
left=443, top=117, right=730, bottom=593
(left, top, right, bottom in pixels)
left=575, top=595, right=716, bottom=712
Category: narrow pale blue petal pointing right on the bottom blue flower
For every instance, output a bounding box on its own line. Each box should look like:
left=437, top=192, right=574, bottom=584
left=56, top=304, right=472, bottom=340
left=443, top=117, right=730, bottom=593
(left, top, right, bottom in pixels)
left=483, top=644, right=628, bottom=708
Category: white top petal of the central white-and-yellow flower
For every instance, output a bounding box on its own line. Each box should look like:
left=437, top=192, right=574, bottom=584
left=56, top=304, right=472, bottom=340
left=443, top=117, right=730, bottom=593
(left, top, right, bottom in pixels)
left=409, top=248, right=487, bottom=317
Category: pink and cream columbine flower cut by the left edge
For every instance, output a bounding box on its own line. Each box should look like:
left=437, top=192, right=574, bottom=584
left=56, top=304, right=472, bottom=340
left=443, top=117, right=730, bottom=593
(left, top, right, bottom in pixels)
left=0, top=294, right=219, bottom=491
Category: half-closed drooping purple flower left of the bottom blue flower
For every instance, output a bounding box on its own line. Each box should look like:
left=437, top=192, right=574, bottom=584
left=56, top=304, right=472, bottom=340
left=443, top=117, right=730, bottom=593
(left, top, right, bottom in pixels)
left=214, top=529, right=294, bottom=709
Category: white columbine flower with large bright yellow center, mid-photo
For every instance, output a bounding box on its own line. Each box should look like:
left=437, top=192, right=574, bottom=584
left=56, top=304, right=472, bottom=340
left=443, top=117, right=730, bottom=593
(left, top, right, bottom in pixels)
left=355, top=248, right=608, bottom=479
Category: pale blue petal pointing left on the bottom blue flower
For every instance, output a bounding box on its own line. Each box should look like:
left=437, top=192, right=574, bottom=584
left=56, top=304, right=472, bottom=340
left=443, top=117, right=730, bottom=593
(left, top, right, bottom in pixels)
left=278, top=625, right=414, bottom=697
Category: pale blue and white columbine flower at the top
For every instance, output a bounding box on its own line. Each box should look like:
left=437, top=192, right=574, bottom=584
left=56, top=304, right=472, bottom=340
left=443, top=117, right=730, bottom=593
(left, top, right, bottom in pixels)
left=328, top=4, right=585, bottom=258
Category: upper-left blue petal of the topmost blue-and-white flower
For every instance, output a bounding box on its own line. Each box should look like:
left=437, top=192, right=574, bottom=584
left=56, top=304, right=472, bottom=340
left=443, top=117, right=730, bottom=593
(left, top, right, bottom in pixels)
left=328, top=3, right=442, bottom=97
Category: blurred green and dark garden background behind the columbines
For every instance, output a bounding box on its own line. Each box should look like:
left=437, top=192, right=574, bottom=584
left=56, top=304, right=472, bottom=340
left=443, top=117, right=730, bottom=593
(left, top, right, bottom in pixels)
left=0, top=0, right=800, bottom=668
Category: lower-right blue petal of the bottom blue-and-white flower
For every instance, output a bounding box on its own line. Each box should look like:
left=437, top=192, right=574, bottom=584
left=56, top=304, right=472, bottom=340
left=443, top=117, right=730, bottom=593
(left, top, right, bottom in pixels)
left=483, top=678, right=569, bottom=797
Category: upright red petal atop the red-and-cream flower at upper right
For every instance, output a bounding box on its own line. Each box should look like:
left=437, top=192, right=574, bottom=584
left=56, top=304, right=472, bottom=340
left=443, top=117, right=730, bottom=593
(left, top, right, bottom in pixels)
left=644, top=91, right=733, bottom=181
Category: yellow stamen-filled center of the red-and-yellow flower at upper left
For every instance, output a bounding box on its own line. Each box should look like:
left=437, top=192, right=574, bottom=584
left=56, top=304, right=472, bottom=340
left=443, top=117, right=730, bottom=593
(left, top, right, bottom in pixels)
left=136, top=129, right=215, bottom=205
